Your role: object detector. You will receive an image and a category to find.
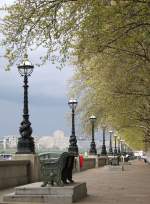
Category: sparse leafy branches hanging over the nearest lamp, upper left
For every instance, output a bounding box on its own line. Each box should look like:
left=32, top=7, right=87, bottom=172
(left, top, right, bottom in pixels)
left=1, top=0, right=86, bottom=66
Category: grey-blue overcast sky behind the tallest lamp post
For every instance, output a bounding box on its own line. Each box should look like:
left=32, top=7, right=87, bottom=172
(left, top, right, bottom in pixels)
left=0, top=0, right=72, bottom=136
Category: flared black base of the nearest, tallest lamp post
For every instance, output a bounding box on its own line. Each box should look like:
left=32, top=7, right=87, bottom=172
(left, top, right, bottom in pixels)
left=16, top=137, right=35, bottom=154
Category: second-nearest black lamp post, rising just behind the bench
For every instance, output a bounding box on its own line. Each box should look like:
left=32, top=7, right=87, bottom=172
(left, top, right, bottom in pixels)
left=68, top=99, right=78, bottom=156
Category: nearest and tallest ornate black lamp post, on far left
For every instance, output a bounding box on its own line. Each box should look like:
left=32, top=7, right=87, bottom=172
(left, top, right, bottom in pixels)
left=17, top=54, right=35, bottom=154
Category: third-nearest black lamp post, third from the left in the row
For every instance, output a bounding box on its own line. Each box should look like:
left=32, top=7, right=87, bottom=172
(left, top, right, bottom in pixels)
left=89, top=115, right=97, bottom=155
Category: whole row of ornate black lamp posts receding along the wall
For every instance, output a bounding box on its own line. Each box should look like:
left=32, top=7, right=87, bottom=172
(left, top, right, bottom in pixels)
left=17, top=54, right=131, bottom=156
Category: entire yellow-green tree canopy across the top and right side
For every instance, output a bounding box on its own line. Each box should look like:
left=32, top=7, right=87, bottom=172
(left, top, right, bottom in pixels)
left=1, top=0, right=150, bottom=148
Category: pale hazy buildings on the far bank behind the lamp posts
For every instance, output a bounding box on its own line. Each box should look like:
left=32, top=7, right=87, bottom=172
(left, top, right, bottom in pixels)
left=0, top=130, right=109, bottom=153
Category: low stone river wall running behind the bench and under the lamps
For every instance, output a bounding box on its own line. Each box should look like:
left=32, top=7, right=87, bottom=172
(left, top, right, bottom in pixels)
left=0, top=155, right=107, bottom=189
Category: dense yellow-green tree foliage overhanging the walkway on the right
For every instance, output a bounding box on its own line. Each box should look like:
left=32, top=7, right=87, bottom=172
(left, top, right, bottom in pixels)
left=69, top=1, right=150, bottom=148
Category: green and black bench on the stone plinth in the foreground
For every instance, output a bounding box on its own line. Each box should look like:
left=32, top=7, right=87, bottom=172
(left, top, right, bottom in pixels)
left=39, top=152, right=75, bottom=187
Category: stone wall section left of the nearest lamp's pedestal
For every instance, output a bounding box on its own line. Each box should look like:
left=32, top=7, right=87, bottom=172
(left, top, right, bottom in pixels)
left=0, top=160, right=30, bottom=189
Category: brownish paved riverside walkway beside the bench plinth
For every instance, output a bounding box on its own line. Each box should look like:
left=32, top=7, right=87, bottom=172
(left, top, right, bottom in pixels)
left=0, top=161, right=150, bottom=204
